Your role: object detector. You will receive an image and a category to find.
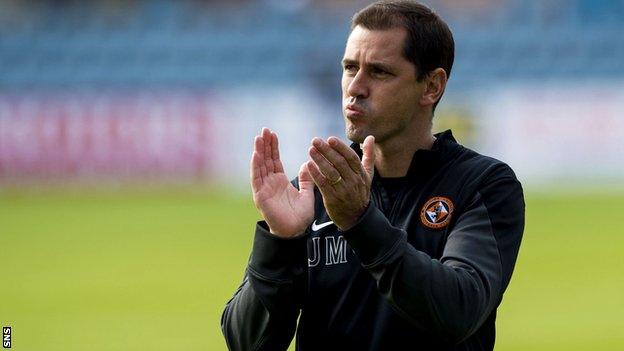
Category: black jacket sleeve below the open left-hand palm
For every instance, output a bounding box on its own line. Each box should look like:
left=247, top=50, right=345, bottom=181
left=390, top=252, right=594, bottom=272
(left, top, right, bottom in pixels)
left=221, top=221, right=306, bottom=351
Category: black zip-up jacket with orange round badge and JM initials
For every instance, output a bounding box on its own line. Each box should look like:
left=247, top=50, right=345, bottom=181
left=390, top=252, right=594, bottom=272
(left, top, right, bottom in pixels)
left=221, top=131, right=524, bottom=351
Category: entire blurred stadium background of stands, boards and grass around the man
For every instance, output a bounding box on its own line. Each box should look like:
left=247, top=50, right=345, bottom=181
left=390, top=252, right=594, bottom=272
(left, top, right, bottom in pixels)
left=0, top=0, right=624, bottom=350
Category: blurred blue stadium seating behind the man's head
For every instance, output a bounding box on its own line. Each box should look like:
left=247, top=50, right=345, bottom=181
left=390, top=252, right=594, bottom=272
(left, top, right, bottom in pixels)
left=0, top=0, right=624, bottom=89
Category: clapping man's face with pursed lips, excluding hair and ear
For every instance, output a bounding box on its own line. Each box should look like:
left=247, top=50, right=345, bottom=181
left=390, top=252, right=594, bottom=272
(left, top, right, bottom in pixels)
left=342, top=26, right=424, bottom=143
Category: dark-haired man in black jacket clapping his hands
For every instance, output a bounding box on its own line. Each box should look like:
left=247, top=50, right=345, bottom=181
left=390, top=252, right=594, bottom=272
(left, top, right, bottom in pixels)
left=222, top=1, right=524, bottom=351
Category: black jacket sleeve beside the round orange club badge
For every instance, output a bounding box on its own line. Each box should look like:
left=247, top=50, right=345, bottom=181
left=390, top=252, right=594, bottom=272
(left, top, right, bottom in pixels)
left=343, top=165, right=524, bottom=343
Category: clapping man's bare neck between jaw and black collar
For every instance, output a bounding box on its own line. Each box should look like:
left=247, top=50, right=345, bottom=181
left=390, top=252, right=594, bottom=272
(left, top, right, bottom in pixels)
left=375, top=119, right=435, bottom=178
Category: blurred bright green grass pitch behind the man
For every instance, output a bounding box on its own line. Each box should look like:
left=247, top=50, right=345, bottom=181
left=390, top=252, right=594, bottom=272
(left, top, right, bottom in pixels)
left=0, top=189, right=624, bottom=351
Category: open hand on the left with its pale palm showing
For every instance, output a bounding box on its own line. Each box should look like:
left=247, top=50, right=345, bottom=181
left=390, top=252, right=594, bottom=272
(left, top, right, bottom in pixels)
left=251, top=128, right=314, bottom=237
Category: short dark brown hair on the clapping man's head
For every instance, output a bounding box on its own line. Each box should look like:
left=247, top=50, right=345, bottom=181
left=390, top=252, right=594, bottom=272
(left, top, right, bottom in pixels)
left=350, top=0, right=455, bottom=88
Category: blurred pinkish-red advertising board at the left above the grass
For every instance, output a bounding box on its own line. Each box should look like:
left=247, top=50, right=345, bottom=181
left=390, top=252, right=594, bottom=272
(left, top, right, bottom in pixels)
left=0, top=93, right=213, bottom=180
